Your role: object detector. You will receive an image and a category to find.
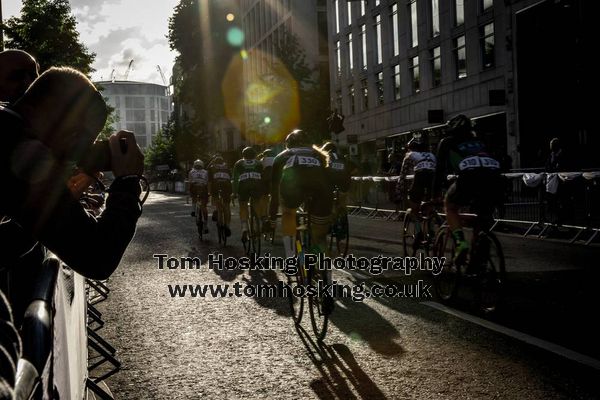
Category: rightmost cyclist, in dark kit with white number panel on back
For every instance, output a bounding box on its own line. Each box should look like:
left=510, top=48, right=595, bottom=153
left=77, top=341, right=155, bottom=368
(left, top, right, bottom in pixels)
left=433, top=114, right=504, bottom=265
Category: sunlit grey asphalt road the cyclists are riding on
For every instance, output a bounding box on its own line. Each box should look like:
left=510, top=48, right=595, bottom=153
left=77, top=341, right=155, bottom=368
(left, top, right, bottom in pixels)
left=94, top=193, right=600, bottom=399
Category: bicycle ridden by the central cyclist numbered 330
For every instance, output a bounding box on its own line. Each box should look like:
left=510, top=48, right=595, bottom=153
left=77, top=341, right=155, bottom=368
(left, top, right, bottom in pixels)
left=288, top=202, right=334, bottom=341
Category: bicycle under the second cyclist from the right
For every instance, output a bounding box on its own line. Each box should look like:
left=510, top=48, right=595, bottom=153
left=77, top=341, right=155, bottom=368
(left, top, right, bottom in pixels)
left=402, top=201, right=442, bottom=257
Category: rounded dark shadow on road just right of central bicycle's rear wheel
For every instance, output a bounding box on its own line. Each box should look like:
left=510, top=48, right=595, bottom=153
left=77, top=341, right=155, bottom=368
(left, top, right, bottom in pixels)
left=329, top=297, right=404, bottom=356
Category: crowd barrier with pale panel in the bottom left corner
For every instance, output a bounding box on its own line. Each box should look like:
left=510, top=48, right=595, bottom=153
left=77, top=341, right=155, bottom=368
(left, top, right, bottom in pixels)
left=9, top=254, right=121, bottom=400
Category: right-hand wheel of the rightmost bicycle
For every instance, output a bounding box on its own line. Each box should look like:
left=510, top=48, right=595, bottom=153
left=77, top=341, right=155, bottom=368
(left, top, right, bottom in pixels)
left=471, top=232, right=506, bottom=314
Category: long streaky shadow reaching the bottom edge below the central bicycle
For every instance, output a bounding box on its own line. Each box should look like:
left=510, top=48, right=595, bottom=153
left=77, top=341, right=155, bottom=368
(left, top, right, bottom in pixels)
left=296, top=325, right=386, bottom=399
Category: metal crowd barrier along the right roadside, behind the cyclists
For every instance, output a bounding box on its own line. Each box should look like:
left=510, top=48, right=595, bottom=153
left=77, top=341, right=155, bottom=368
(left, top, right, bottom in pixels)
left=348, top=171, right=600, bottom=244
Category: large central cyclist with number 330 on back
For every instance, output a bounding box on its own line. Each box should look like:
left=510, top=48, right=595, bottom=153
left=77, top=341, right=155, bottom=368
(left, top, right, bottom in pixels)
left=270, top=129, right=332, bottom=257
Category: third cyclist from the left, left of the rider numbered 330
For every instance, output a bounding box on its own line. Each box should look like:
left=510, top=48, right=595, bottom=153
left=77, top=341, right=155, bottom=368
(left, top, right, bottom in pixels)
left=233, top=147, right=264, bottom=242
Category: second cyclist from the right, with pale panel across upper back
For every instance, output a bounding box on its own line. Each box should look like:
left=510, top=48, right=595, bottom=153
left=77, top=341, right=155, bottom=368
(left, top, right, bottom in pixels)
left=397, top=137, right=436, bottom=245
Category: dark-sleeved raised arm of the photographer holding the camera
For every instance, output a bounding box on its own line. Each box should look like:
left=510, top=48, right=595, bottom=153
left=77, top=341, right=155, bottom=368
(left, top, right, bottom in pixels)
left=15, top=132, right=143, bottom=279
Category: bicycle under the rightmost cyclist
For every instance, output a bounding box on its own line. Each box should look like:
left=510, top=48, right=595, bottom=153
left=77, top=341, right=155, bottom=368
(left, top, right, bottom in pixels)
left=434, top=208, right=506, bottom=314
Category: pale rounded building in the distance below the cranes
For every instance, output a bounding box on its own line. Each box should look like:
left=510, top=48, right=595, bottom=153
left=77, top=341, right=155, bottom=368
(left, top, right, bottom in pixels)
left=96, top=81, right=173, bottom=148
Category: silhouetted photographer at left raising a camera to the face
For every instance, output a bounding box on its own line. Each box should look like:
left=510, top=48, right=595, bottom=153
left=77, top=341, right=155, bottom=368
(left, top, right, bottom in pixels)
left=0, top=68, right=143, bottom=279
